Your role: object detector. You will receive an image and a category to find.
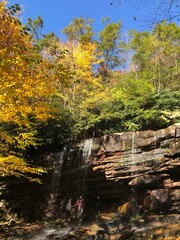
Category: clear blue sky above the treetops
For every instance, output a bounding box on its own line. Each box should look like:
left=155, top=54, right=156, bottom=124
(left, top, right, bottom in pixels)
left=9, top=0, right=179, bottom=37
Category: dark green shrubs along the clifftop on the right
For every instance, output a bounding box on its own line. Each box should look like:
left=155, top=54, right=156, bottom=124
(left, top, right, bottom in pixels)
left=95, top=90, right=180, bottom=133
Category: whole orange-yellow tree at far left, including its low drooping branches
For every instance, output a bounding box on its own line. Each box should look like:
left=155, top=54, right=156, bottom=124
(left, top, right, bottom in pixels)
left=0, top=2, right=61, bottom=182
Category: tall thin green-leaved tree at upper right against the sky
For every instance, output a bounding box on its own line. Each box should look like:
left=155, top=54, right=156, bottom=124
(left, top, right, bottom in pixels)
left=131, top=22, right=180, bottom=92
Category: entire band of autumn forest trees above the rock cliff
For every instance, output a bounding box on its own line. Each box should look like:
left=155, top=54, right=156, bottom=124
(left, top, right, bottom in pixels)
left=0, top=2, right=180, bottom=180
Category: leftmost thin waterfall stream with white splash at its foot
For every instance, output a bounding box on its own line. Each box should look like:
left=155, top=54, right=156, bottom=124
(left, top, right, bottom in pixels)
left=24, top=144, right=83, bottom=240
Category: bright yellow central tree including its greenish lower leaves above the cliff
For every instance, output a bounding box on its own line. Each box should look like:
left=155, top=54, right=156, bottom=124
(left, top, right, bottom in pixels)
left=52, top=41, right=103, bottom=134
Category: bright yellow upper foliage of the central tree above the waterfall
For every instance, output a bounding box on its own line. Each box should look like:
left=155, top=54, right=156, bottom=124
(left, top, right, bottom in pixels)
left=45, top=41, right=104, bottom=117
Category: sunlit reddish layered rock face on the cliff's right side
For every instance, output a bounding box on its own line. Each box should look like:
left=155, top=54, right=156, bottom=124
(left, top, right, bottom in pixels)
left=92, top=124, right=180, bottom=213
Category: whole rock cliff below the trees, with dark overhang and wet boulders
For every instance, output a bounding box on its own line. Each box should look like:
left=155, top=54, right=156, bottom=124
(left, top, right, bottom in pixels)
left=1, top=124, right=180, bottom=240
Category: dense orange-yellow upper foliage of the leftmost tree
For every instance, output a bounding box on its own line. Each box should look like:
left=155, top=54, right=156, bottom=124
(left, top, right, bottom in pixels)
left=0, top=3, right=50, bottom=124
